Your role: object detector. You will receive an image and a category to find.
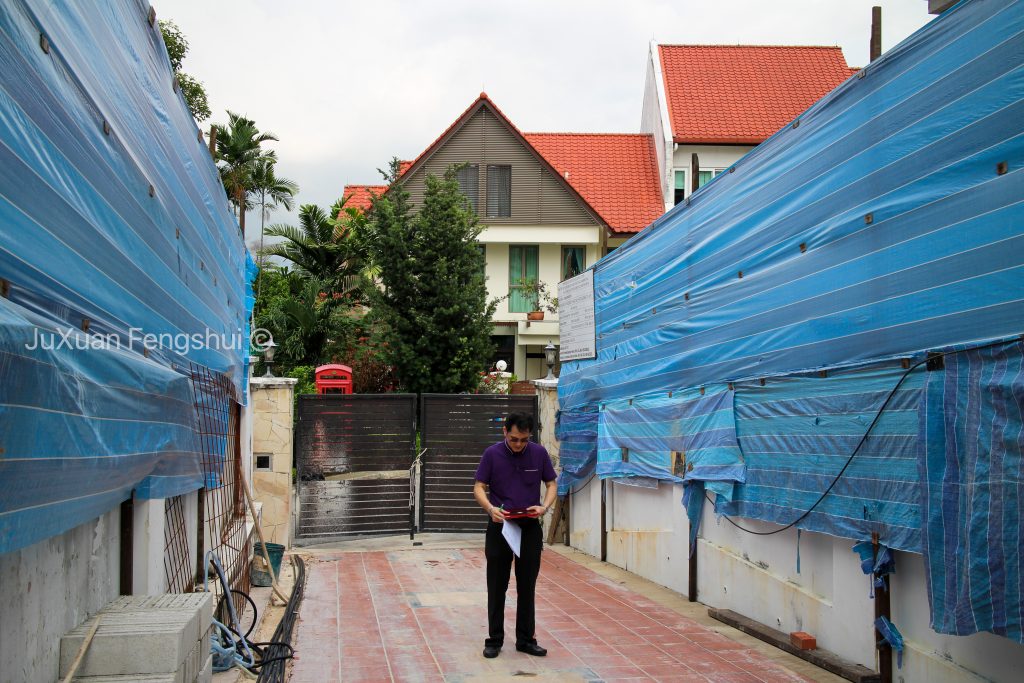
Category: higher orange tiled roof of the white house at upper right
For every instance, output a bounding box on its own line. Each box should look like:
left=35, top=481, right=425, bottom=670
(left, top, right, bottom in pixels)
left=657, top=45, right=857, bottom=144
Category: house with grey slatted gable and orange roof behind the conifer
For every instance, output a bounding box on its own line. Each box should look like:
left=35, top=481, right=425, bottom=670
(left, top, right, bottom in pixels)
left=343, top=93, right=665, bottom=379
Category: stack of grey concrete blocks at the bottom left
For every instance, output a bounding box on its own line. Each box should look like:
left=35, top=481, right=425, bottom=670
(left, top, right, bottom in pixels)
left=60, top=593, right=213, bottom=683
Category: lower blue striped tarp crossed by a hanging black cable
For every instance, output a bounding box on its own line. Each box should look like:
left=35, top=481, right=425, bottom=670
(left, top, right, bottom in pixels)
left=716, top=362, right=925, bottom=552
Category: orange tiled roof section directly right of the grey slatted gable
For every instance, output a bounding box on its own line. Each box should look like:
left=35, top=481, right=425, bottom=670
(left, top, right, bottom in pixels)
left=524, top=133, right=665, bottom=232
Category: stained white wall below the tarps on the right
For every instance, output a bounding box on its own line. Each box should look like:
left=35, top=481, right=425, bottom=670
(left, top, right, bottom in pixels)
left=569, top=478, right=1024, bottom=683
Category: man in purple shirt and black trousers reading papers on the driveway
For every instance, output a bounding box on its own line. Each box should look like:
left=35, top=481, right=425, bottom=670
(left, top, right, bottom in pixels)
left=473, top=413, right=558, bottom=658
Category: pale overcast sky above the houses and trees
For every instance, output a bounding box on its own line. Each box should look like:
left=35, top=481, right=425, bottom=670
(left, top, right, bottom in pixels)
left=155, top=0, right=933, bottom=245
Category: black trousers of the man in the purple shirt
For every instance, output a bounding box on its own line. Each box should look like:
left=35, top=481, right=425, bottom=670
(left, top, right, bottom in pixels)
left=483, top=517, right=544, bottom=647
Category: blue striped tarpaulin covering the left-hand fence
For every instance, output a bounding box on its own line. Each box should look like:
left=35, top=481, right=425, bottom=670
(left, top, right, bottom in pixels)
left=0, top=0, right=251, bottom=552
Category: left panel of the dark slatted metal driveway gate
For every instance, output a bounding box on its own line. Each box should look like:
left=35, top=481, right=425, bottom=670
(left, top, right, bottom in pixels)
left=295, top=394, right=416, bottom=545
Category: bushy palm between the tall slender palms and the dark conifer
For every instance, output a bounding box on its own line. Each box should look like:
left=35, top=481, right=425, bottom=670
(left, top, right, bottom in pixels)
left=260, top=198, right=367, bottom=298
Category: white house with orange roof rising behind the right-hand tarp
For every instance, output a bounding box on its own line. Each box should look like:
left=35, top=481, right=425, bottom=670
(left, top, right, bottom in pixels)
left=640, top=43, right=857, bottom=210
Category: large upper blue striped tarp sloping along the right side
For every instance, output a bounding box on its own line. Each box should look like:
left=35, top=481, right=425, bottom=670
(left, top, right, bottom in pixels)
left=559, top=0, right=1024, bottom=409
